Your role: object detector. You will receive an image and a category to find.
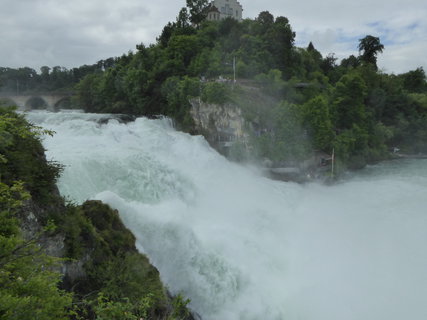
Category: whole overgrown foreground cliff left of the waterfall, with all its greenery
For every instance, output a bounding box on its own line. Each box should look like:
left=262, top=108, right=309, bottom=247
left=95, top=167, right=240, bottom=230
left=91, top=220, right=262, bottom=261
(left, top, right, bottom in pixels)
left=0, top=107, right=191, bottom=320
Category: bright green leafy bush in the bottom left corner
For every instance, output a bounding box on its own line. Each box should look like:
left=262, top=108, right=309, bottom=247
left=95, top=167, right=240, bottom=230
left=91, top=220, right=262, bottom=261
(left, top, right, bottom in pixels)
left=0, top=162, right=72, bottom=320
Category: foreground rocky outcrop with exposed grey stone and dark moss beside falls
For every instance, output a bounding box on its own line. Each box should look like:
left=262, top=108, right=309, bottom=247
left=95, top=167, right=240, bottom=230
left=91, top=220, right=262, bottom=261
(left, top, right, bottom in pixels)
left=19, top=194, right=194, bottom=320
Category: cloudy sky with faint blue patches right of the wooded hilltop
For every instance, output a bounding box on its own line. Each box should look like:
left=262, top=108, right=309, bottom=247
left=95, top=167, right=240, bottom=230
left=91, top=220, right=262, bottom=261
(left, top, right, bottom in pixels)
left=245, top=0, right=427, bottom=72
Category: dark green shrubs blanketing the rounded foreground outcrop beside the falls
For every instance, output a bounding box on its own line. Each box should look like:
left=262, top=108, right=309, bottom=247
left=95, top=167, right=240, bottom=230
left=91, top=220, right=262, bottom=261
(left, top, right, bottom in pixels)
left=59, top=201, right=188, bottom=320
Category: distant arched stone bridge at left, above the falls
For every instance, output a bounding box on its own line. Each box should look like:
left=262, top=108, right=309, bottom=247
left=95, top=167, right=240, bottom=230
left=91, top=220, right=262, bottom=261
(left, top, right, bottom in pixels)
left=0, top=93, right=72, bottom=112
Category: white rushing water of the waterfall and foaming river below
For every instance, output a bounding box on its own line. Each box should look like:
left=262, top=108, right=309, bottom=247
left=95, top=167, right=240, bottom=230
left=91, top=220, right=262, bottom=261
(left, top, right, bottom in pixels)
left=28, top=112, right=427, bottom=320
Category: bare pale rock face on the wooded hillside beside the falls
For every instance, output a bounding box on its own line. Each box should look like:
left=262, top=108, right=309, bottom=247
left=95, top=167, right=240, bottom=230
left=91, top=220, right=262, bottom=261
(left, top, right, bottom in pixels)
left=190, top=99, right=250, bottom=154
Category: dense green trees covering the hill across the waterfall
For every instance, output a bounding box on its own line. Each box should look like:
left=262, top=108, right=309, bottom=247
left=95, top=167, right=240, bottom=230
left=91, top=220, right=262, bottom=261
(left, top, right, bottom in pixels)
left=66, top=5, right=427, bottom=167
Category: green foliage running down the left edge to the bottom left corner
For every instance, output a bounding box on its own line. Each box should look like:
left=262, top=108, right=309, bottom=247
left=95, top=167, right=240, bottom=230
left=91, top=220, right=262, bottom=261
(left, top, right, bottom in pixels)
left=0, top=108, right=72, bottom=320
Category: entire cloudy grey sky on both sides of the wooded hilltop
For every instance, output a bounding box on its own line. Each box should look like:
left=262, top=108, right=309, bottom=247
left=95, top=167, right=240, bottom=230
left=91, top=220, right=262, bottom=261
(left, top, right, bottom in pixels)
left=0, top=0, right=427, bottom=73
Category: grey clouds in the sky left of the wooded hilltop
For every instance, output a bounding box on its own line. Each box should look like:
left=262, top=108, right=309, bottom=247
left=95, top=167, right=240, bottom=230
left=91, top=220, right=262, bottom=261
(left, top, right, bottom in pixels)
left=0, top=0, right=160, bottom=69
